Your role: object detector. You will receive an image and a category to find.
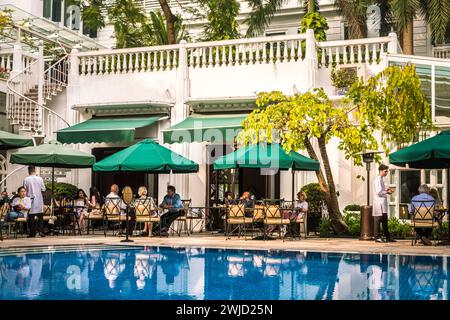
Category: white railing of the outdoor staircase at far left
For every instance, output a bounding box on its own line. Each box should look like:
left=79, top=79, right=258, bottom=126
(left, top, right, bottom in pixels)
left=6, top=55, right=69, bottom=140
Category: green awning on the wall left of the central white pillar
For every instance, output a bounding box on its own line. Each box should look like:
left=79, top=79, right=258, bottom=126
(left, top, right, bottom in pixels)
left=56, top=115, right=161, bottom=143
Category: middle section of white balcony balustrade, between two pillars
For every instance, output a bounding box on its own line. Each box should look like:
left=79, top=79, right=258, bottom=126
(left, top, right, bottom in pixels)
left=186, top=34, right=306, bottom=68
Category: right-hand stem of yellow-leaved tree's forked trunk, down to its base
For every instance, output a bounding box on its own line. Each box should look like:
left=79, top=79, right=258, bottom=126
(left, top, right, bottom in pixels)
left=318, top=134, right=348, bottom=234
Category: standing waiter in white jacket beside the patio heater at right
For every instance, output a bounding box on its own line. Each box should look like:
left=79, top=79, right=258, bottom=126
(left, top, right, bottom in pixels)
left=372, top=164, right=395, bottom=242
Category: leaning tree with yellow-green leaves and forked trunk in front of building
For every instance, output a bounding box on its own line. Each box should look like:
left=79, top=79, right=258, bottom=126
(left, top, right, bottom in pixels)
left=238, top=65, right=432, bottom=234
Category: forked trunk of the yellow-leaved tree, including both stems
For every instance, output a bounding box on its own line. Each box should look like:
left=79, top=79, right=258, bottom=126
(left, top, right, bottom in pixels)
left=305, top=139, right=348, bottom=234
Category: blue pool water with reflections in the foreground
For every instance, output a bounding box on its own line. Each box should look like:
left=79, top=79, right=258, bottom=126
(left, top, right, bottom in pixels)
left=0, top=246, right=450, bottom=300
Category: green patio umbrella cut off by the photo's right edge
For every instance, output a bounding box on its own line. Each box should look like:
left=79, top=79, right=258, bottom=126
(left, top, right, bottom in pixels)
left=389, top=130, right=450, bottom=169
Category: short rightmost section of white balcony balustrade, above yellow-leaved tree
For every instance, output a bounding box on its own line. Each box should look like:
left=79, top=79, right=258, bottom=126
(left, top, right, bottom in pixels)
left=317, top=37, right=397, bottom=68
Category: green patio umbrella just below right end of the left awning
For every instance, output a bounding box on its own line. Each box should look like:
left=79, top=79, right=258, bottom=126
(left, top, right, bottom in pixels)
left=93, top=139, right=198, bottom=173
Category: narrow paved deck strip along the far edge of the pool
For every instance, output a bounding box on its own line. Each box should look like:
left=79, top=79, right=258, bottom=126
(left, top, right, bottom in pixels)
left=0, top=234, right=450, bottom=256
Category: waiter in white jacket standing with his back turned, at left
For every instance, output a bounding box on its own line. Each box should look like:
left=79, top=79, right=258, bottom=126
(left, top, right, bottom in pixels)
left=23, top=166, right=45, bottom=238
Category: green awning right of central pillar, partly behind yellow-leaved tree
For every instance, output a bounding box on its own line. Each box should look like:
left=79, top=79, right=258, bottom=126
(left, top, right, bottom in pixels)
left=163, top=114, right=247, bottom=143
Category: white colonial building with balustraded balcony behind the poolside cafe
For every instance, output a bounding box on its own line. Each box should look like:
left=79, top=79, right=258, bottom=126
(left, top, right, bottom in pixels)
left=0, top=0, right=450, bottom=219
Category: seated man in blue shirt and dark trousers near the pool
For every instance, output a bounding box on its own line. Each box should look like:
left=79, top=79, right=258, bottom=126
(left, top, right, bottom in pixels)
left=153, top=186, right=183, bottom=236
